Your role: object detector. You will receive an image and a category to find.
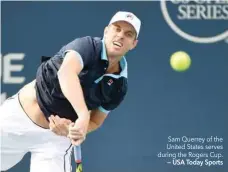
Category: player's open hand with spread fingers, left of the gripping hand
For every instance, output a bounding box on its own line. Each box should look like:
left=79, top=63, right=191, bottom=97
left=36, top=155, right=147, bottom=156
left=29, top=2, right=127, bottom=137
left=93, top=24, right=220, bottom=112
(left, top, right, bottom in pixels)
left=48, top=115, right=72, bottom=137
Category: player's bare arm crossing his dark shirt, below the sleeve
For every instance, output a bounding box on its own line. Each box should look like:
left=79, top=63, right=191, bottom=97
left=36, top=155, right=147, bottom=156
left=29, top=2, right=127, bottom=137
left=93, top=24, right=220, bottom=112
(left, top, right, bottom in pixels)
left=58, top=51, right=90, bottom=141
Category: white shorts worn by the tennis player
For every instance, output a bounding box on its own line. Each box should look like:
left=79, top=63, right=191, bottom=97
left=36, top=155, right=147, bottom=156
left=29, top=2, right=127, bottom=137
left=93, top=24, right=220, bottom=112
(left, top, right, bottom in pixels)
left=0, top=95, right=72, bottom=172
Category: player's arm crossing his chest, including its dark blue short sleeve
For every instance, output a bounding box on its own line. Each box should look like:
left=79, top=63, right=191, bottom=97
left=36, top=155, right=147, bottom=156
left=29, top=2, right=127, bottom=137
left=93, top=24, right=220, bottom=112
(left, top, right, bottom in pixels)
left=58, top=37, right=93, bottom=145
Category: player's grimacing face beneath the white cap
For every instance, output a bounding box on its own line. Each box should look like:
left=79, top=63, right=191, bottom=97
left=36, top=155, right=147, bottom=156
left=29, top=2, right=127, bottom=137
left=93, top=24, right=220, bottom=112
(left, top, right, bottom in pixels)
left=104, top=21, right=138, bottom=57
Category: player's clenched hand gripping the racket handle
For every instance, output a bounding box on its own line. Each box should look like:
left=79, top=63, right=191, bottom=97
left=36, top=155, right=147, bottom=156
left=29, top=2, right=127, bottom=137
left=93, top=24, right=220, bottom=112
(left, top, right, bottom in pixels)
left=68, top=118, right=89, bottom=145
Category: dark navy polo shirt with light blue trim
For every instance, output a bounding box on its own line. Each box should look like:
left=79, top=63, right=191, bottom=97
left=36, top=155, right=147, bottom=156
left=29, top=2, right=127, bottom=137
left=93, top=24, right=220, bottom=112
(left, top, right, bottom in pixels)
left=36, top=36, right=127, bottom=121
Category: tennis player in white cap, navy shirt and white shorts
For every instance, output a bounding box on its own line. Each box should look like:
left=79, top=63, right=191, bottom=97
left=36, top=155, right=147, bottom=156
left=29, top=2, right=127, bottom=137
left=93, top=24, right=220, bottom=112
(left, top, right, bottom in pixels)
left=0, top=11, right=141, bottom=172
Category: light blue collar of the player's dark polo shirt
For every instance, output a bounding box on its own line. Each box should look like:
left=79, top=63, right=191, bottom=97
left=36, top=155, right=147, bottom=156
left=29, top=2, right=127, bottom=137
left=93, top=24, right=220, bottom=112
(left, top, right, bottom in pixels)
left=101, top=39, right=127, bottom=78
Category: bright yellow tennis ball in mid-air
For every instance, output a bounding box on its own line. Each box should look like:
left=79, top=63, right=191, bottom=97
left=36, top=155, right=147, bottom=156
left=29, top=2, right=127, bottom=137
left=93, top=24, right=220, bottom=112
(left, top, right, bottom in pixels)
left=170, top=51, right=191, bottom=72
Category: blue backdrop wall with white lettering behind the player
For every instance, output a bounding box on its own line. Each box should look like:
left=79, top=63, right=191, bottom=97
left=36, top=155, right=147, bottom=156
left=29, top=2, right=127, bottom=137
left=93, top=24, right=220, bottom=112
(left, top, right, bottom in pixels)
left=1, top=0, right=228, bottom=172
